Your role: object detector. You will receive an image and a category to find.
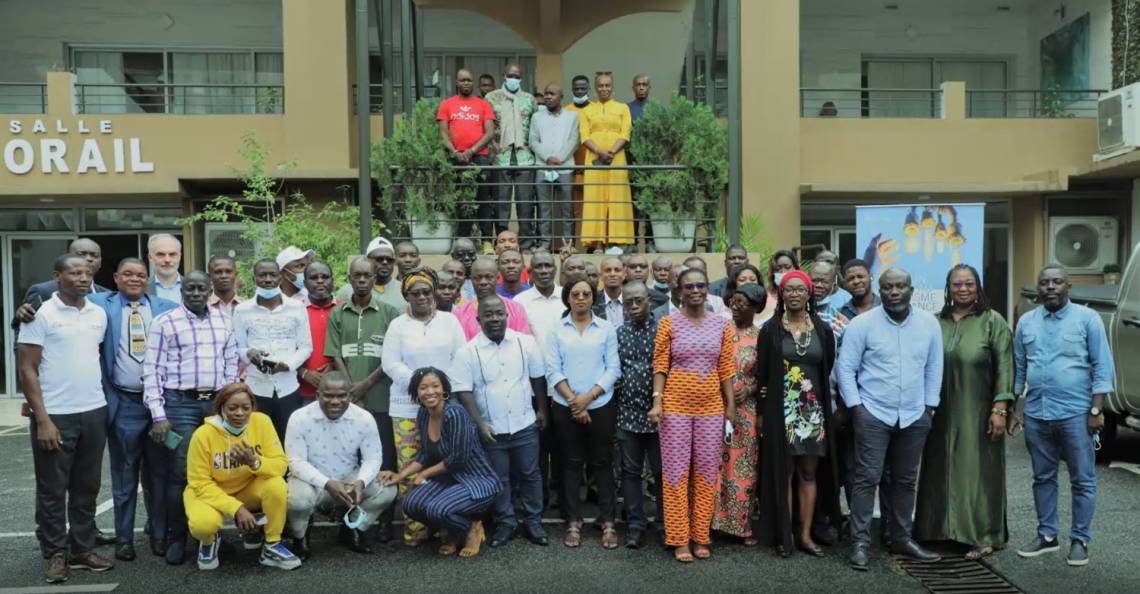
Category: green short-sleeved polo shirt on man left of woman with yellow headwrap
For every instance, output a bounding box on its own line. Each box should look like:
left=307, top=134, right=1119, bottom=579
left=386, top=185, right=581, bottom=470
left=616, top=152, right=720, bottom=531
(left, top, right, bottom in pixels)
left=325, top=295, right=402, bottom=413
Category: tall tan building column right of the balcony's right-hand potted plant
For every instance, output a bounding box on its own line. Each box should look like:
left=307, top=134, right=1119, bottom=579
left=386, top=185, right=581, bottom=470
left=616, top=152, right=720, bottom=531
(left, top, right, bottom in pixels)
left=740, top=0, right=800, bottom=249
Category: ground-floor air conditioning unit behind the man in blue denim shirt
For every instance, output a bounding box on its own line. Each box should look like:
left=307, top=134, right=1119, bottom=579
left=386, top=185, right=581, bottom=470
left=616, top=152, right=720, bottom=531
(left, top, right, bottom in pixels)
left=1048, top=217, right=1119, bottom=275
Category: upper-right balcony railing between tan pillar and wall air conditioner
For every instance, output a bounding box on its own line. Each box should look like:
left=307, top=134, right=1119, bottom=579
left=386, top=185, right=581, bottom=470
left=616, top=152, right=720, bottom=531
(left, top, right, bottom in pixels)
left=966, top=89, right=1108, bottom=117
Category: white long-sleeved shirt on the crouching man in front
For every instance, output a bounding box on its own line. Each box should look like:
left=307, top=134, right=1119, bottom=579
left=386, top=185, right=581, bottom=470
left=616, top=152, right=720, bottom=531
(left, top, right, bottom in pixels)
left=285, top=402, right=384, bottom=489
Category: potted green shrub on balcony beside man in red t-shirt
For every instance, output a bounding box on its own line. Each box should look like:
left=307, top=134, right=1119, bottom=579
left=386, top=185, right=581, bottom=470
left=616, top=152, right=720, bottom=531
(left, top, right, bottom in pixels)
left=371, top=98, right=478, bottom=254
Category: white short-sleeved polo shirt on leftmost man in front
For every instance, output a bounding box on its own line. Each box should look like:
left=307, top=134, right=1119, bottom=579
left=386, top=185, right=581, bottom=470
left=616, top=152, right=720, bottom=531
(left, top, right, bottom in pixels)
left=18, top=292, right=107, bottom=415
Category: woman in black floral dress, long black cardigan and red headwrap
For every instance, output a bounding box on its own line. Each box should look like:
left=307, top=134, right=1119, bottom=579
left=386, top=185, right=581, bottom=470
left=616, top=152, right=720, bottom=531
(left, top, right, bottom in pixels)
left=756, top=270, right=840, bottom=556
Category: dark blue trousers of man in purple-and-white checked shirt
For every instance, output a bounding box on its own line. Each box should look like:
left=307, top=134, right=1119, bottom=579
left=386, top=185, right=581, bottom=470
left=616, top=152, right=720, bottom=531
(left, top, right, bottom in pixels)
left=147, top=390, right=213, bottom=542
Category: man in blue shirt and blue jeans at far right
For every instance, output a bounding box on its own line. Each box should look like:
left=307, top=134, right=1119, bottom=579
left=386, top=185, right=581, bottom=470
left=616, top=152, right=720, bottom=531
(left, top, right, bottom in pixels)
left=1013, top=265, right=1113, bottom=565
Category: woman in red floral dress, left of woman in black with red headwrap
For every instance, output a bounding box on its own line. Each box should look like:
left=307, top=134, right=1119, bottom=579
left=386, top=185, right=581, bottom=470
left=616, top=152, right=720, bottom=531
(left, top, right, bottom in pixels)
left=713, top=283, right=765, bottom=546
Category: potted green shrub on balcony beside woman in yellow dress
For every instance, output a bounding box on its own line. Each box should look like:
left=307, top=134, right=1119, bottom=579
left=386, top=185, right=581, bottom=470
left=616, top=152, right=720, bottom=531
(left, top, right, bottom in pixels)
left=629, top=93, right=728, bottom=252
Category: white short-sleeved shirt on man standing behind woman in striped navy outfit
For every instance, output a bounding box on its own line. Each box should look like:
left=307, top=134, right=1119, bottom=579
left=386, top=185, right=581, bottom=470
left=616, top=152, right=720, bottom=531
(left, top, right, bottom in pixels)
left=449, top=328, right=546, bottom=436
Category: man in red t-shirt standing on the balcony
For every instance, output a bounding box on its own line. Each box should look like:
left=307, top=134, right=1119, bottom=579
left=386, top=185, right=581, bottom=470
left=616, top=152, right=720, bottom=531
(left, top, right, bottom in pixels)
left=435, top=68, right=495, bottom=251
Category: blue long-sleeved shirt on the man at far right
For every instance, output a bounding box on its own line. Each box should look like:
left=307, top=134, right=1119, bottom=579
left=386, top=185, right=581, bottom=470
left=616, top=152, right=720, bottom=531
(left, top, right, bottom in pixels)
left=1013, top=303, right=1113, bottom=421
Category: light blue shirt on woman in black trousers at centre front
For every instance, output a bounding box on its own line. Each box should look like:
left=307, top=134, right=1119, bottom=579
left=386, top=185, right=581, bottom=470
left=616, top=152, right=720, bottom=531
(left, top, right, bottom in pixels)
left=545, top=316, right=621, bottom=410
